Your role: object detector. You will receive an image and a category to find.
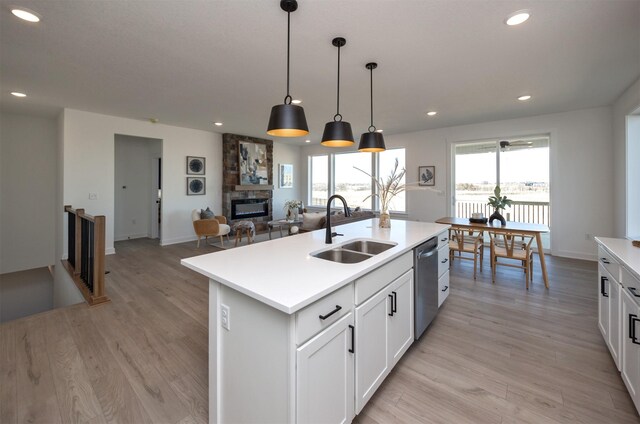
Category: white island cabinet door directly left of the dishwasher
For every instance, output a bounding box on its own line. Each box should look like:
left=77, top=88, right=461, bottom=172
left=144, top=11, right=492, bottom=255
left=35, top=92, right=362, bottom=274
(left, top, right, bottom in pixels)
left=387, top=270, right=414, bottom=368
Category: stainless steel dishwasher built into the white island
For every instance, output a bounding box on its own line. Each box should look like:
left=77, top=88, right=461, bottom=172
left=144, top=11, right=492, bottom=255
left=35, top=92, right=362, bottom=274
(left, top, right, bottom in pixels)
left=413, top=237, right=438, bottom=340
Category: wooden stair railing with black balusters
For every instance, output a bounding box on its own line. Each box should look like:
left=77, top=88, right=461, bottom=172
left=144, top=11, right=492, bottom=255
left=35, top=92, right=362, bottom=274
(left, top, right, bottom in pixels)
left=62, top=205, right=110, bottom=305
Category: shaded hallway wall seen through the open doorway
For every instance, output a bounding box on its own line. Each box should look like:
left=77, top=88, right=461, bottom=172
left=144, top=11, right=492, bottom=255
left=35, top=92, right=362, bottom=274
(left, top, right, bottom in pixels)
left=114, top=134, right=162, bottom=241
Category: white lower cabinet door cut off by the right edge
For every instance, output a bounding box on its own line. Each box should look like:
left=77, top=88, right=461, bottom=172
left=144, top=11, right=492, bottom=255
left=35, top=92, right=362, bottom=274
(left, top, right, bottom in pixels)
left=621, top=289, right=640, bottom=410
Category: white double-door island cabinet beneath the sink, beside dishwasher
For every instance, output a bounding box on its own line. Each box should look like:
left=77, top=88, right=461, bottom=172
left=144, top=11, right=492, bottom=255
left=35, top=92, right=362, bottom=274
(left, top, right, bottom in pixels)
left=355, top=269, right=413, bottom=413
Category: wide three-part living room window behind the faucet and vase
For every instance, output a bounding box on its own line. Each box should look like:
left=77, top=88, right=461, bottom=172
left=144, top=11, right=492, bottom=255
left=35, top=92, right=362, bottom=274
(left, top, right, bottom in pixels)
left=307, top=149, right=406, bottom=212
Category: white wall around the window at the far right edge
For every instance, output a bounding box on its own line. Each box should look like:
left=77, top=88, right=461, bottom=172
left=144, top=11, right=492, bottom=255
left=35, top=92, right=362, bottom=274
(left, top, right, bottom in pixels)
left=612, top=79, right=640, bottom=237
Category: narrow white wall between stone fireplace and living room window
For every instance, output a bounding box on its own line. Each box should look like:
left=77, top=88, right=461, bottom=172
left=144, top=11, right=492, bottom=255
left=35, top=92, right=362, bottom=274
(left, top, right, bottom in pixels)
left=273, top=143, right=305, bottom=219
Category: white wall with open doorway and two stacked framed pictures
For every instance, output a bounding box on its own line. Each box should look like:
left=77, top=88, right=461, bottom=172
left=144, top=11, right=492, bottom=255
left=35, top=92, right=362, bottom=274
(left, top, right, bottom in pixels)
left=63, top=109, right=222, bottom=253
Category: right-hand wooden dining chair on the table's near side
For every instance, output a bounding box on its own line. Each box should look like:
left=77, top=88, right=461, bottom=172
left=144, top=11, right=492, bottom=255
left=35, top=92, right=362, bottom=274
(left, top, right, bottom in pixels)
left=489, top=232, right=534, bottom=290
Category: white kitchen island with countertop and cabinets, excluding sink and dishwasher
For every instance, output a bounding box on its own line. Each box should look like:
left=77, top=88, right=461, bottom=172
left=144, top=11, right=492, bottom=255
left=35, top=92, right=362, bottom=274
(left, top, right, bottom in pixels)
left=182, top=219, right=448, bottom=423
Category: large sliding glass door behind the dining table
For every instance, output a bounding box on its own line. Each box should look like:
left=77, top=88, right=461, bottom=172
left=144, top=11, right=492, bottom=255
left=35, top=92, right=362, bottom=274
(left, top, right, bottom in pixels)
left=451, top=134, right=551, bottom=250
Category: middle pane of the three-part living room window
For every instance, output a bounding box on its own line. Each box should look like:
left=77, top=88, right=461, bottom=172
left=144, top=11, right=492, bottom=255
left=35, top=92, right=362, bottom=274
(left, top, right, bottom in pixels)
left=333, top=152, right=373, bottom=209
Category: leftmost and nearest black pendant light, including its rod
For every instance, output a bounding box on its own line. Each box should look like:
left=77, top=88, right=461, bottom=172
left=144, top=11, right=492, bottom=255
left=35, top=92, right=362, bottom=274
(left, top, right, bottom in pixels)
left=267, top=0, right=309, bottom=137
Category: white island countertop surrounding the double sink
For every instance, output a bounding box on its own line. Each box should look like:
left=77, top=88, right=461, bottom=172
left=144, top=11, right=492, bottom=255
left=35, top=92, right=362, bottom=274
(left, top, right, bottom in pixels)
left=180, top=218, right=450, bottom=314
